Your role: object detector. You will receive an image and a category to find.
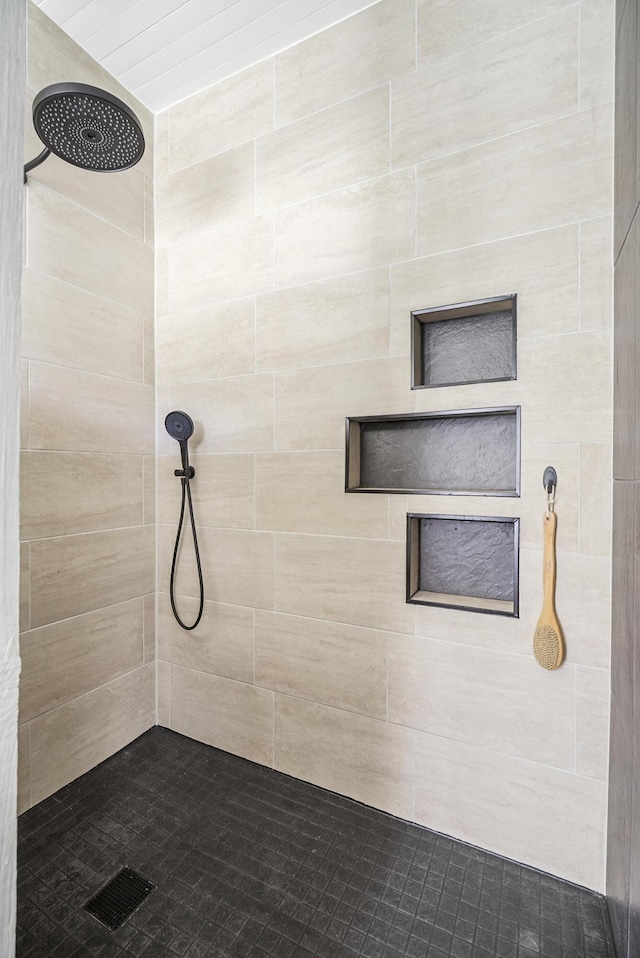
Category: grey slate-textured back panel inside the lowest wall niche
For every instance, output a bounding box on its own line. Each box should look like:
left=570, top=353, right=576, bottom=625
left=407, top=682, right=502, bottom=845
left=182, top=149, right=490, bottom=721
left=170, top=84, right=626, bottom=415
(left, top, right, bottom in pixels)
left=418, top=519, right=515, bottom=602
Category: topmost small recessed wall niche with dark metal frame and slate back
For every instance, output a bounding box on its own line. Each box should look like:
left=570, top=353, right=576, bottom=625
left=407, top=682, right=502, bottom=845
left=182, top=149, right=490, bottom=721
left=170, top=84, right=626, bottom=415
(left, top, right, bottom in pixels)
left=411, top=294, right=517, bottom=389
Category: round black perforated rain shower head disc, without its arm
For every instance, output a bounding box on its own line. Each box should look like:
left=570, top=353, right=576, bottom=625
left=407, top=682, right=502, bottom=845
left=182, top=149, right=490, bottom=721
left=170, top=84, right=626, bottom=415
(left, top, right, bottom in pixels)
left=33, top=83, right=144, bottom=173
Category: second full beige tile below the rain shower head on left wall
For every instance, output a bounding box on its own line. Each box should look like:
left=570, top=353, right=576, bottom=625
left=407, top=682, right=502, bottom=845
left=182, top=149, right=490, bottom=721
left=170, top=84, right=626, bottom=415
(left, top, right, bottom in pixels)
left=22, top=270, right=143, bottom=382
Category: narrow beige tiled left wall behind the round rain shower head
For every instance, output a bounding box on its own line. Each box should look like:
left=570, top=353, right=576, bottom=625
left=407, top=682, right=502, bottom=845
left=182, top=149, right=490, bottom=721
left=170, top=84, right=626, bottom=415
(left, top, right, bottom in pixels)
left=19, top=4, right=156, bottom=811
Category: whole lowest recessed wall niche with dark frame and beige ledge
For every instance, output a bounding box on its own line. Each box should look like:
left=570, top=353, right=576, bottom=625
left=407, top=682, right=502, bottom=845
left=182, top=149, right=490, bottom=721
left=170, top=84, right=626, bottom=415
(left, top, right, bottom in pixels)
left=407, top=513, right=520, bottom=618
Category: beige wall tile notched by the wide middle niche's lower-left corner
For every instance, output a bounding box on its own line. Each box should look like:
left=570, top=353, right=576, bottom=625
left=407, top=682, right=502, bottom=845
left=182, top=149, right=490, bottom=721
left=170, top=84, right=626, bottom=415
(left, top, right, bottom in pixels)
left=255, top=451, right=388, bottom=539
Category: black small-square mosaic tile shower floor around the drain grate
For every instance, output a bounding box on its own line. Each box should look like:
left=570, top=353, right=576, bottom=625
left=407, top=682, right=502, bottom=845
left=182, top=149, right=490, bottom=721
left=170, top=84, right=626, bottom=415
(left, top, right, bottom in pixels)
left=17, top=728, right=614, bottom=958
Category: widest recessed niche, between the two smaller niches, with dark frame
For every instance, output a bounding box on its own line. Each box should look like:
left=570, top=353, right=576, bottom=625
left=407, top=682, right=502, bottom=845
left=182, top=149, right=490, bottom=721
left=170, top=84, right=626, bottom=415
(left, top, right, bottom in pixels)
left=345, top=406, right=520, bottom=496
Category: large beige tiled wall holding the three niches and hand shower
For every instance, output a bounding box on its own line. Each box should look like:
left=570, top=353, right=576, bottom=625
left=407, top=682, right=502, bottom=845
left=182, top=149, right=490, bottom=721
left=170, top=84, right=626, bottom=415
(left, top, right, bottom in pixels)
left=156, top=0, right=613, bottom=889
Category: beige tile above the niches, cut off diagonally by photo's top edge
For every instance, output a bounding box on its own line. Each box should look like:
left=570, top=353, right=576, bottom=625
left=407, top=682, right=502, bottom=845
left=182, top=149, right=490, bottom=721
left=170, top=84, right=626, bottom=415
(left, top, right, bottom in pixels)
left=418, top=0, right=572, bottom=63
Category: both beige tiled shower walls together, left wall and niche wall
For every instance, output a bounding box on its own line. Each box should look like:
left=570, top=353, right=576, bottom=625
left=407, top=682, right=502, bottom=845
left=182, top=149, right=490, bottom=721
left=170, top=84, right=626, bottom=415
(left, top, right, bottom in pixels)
left=2, top=0, right=633, bottom=956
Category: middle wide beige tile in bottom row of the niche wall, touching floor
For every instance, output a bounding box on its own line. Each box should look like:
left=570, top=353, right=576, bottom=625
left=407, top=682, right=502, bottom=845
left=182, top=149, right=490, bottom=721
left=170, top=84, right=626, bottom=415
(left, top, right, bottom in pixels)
left=274, top=694, right=414, bottom=819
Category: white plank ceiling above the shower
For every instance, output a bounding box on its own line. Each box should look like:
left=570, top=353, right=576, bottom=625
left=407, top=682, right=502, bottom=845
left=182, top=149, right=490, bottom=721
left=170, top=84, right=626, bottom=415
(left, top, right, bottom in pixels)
left=35, top=0, right=376, bottom=112
